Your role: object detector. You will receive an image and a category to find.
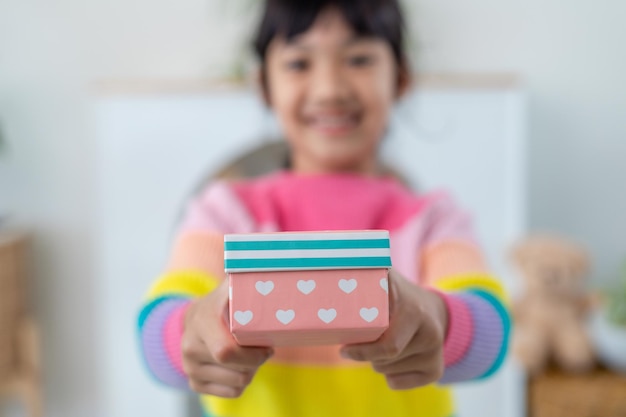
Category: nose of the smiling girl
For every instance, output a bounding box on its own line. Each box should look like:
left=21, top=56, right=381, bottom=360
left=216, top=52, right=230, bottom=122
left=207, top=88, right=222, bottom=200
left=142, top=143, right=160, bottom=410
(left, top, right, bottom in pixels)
left=308, top=63, right=350, bottom=105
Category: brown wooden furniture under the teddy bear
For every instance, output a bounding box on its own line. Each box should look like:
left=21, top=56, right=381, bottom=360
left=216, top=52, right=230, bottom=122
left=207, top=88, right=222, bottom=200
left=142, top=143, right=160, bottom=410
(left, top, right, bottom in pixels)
left=528, top=368, right=626, bottom=417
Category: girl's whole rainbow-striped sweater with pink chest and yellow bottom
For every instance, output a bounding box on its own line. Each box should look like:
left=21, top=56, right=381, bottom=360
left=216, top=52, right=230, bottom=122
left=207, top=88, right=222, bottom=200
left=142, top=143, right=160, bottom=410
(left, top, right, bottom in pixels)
left=138, top=172, right=509, bottom=417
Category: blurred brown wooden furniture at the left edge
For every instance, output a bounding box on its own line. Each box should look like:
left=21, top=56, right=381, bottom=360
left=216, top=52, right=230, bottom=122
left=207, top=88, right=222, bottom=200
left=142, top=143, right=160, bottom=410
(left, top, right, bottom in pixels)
left=0, top=231, right=42, bottom=417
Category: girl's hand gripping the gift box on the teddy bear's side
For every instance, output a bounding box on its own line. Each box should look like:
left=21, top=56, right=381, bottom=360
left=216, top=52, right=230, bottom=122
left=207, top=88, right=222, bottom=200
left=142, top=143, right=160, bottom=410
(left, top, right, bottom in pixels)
left=341, top=270, right=448, bottom=389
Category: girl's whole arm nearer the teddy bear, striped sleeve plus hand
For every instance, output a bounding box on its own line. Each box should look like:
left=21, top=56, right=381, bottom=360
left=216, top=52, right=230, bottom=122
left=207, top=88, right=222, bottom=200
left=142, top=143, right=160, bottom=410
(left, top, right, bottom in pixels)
left=341, top=192, right=509, bottom=389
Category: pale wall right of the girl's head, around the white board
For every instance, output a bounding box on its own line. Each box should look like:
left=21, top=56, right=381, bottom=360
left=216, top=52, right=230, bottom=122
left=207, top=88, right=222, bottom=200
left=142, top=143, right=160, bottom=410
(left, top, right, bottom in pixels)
left=415, top=0, right=626, bottom=280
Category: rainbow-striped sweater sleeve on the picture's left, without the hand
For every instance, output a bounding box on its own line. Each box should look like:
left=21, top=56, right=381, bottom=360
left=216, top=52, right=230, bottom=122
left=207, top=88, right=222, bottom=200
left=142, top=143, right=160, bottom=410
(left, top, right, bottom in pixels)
left=138, top=183, right=253, bottom=388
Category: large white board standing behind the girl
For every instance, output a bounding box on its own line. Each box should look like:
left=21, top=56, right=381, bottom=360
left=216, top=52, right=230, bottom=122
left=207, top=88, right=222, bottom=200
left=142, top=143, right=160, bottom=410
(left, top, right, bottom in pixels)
left=95, top=89, right=526, bottom=417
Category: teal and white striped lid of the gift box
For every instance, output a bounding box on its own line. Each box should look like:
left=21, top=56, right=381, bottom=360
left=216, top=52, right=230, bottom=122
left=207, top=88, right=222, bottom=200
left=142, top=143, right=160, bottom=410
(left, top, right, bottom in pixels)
left=224, top=230, right=391, bottom=273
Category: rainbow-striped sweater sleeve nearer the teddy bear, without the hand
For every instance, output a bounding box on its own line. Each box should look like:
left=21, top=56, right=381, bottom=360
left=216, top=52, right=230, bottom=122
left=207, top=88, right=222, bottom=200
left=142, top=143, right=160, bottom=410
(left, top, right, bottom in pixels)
left=419, top=198, right=510, bottom=383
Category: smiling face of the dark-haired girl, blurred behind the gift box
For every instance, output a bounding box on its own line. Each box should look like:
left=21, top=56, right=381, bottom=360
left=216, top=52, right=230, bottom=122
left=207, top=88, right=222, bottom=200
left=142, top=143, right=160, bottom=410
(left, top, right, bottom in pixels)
left=266, top=8, right=407, bottom=174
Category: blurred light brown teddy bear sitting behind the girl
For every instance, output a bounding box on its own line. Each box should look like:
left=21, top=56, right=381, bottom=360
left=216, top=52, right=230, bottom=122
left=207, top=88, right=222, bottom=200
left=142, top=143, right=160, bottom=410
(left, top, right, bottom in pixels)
left=512, top=236, right=594, bottom=374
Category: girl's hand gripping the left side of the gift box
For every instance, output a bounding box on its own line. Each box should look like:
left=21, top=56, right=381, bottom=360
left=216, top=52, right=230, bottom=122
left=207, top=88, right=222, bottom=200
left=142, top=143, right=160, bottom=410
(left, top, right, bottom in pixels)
left=182, top=280, right=272, bottom=398
